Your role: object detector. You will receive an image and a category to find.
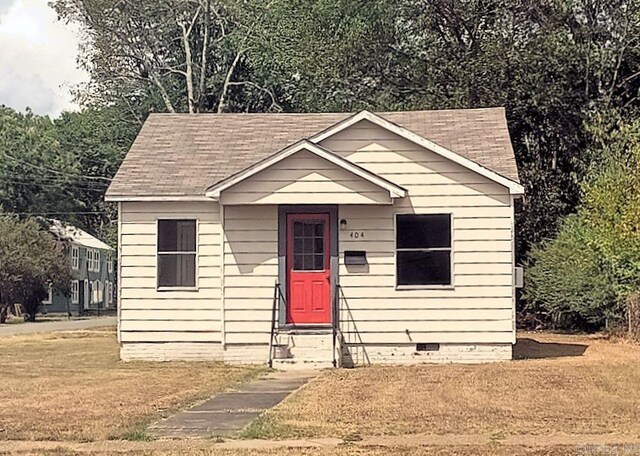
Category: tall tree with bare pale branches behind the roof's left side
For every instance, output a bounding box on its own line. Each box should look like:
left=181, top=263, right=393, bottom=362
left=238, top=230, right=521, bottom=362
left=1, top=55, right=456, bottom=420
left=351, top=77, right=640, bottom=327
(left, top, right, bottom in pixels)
left=53, top=0, right=284, bottom=119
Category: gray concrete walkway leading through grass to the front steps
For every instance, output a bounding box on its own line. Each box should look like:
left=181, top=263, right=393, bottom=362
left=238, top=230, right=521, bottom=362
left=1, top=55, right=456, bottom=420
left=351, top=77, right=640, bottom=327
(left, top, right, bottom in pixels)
left=149, top=371, right=318, bottom=438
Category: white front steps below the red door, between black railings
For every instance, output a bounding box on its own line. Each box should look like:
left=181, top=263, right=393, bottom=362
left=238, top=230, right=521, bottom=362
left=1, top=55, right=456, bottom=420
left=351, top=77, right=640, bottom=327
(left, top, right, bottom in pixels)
left=273, top=329, right=339, bottom=370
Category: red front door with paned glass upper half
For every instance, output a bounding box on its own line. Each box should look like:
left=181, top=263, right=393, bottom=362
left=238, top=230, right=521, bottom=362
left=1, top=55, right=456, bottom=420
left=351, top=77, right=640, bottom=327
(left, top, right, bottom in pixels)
left=287, top=214, right=331, bottom=325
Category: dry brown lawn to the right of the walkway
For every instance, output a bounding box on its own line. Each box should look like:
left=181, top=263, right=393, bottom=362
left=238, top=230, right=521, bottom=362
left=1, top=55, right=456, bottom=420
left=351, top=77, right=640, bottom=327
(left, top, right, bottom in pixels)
left=251, top=334, right=640, bottom=438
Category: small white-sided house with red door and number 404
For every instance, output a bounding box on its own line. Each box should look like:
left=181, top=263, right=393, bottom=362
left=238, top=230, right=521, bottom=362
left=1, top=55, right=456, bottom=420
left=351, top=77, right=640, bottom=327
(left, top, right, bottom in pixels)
left=106, top=108, right=523, bottom=368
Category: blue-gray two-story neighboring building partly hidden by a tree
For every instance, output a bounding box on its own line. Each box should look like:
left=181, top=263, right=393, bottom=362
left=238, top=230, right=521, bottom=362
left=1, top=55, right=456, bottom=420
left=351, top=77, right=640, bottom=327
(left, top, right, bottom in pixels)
left=45, top=220, right=116, bottom=315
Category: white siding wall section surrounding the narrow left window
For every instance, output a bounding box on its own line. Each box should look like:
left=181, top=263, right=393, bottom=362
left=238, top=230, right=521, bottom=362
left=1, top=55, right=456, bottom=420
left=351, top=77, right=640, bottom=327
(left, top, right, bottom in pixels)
left=119, top=202, right=222, bottom=348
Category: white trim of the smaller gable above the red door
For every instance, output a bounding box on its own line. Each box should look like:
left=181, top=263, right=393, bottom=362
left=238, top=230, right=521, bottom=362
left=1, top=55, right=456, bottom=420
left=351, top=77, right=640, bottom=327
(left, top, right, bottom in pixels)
left=206, top=139, right=407, bottom=198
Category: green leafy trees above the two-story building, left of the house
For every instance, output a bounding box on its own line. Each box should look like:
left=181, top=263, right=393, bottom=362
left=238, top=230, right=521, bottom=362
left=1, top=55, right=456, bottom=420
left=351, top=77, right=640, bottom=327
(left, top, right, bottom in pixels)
left=0, top=106, right=134, bottom=243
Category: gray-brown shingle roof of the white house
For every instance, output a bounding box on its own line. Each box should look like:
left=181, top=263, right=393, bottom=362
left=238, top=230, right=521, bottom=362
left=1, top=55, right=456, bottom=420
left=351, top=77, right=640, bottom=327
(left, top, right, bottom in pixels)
left=107, top=108, right=519, bottom=198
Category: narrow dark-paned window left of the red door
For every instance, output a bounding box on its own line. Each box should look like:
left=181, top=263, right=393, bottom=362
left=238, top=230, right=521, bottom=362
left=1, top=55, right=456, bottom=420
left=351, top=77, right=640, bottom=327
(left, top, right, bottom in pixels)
left=158, top=220, right=196, bottom=288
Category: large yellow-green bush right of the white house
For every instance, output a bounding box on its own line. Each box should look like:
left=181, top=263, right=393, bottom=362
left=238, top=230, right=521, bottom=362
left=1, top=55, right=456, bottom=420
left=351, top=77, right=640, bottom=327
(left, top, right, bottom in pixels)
left=523, top=117, right=640, bottom=324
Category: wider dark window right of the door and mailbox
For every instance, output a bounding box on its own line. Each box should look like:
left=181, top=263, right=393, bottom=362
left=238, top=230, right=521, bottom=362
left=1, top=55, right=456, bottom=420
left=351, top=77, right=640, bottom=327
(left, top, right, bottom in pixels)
left=396, top=214, right=451, bottom=286
